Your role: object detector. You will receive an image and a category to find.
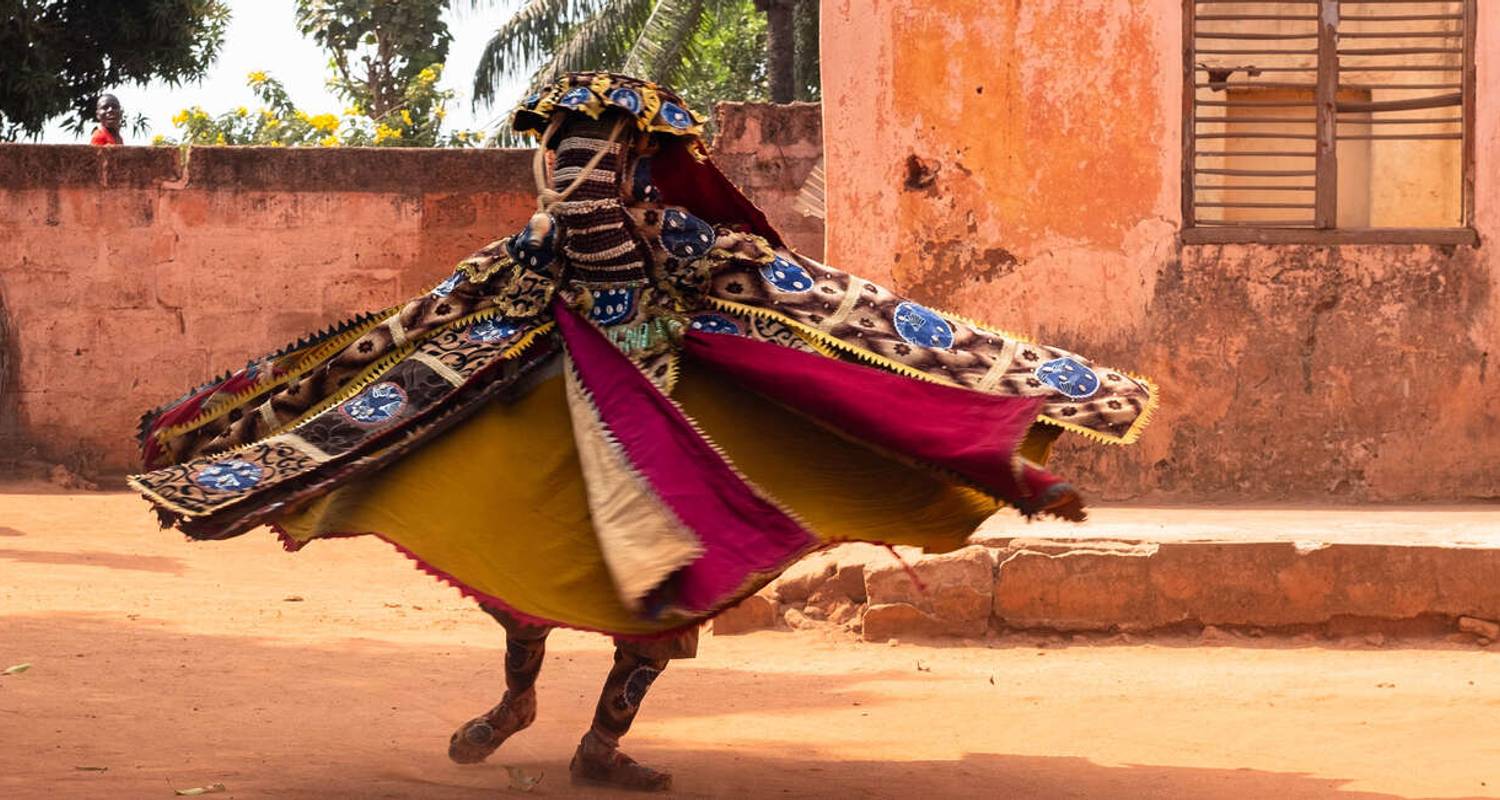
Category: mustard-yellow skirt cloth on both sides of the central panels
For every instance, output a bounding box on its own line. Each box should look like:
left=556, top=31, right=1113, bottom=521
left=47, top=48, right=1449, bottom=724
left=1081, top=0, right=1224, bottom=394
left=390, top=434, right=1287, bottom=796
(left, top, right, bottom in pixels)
left=281, top=363, right=996, bottom=635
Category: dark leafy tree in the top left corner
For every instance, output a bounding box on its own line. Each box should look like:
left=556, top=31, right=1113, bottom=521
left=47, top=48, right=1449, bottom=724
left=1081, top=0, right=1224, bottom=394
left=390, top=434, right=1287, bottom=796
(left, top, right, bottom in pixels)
left=0, top=0, right=230, bottom=140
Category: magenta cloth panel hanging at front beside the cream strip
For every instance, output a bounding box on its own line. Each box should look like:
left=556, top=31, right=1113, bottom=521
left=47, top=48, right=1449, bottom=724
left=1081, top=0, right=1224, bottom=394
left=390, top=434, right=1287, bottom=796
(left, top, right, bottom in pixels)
left=552, top=300, right=818, bottom=612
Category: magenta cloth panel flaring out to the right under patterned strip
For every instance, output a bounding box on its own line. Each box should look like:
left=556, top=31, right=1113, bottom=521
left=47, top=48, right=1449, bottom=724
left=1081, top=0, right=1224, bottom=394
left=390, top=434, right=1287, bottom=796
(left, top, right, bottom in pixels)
left=686, top=330, right=1043, bottom=501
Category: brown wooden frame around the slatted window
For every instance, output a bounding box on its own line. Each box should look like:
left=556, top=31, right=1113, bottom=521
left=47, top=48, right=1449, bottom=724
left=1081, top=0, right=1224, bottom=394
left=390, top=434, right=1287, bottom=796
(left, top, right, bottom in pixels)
left=1179, top=0, right=1476, bottom=246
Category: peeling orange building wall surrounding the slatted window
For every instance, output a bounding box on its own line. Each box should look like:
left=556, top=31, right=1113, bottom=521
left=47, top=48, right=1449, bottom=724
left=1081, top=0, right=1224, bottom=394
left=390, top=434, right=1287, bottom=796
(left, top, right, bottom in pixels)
left=822, top=0, right=1500, bottom=500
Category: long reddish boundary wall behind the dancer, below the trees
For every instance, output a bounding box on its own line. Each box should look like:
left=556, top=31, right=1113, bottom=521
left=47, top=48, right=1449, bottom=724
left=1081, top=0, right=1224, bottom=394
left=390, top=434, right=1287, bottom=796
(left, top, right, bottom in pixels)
left=0, top=107, right=822, bottom=473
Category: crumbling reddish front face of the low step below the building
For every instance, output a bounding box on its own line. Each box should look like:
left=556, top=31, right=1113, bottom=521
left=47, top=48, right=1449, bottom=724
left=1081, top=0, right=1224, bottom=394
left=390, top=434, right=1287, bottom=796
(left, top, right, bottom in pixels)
left=708, top=515, right=1500, bottom=644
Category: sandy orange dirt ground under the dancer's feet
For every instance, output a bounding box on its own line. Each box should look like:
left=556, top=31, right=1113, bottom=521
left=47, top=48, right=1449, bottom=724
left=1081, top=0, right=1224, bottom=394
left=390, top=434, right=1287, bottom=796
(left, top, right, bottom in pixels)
left=0, top=494, right=1500, bottom=800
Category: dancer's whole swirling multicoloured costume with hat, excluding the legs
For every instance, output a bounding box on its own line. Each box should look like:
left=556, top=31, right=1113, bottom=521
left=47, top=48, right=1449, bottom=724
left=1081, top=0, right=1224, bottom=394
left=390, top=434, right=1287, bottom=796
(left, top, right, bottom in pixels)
left=131, top=74, right=1157, bottom=639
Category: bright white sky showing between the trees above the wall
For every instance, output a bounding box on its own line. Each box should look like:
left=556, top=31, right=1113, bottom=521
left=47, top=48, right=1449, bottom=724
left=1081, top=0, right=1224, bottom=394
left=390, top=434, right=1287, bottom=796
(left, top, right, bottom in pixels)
left=41, top=0, right=524, bottom=144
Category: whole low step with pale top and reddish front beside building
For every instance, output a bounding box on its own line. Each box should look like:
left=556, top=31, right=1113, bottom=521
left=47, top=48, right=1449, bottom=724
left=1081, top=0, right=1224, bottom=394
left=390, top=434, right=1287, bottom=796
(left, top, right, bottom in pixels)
left=717, top=507, right=1500, bottom=641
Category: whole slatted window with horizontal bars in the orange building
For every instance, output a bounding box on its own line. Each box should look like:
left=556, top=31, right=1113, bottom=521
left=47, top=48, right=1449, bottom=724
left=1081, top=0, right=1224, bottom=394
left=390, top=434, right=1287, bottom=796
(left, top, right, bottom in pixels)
left=1182, top=0, right=1488, bottom=243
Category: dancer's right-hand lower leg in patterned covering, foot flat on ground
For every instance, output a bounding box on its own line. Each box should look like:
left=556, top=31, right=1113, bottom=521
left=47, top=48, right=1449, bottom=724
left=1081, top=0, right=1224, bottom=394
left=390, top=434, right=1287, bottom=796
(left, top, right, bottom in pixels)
left=569, top=647, right=672, bottom=791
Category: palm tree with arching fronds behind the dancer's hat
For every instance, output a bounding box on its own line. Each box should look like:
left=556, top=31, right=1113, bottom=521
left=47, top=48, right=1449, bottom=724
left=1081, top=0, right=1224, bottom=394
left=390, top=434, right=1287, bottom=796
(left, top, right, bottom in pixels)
left=474, top=0, right=818, bottom=111
